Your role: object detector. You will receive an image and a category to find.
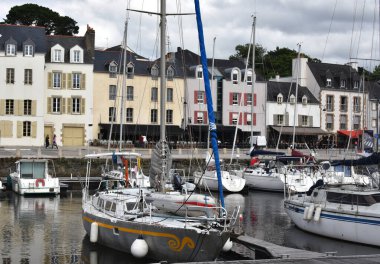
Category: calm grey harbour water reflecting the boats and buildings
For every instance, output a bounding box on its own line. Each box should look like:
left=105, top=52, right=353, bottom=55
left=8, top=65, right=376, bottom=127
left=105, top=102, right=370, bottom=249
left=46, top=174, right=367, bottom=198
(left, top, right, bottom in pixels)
left=0, top=190, right=380, bottom=264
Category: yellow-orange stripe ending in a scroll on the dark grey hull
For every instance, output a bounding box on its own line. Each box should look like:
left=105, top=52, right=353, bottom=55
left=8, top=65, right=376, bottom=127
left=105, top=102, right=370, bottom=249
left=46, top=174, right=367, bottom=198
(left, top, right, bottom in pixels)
left=83, top=216, right=195, bottom=252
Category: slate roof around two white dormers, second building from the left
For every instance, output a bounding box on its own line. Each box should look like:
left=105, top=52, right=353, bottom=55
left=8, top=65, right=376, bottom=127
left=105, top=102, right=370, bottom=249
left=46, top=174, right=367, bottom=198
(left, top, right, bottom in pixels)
left=45, top=35, right=94, bottom=64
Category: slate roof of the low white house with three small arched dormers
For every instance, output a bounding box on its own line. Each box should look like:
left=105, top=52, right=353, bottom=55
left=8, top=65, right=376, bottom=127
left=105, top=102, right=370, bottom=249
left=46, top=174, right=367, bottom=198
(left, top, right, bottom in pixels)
left=267, top=81, right=319, bottom=104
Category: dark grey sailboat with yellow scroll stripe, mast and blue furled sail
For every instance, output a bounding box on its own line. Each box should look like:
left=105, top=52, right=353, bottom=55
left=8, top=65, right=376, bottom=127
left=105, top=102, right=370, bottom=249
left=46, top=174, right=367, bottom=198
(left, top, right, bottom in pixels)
left=82, top=0, right=239, bottom=262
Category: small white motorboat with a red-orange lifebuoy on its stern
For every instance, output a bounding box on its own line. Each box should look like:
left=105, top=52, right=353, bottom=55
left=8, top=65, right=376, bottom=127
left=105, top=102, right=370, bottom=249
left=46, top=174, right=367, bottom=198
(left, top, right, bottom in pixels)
left=7, top=159, right=60, bottom=195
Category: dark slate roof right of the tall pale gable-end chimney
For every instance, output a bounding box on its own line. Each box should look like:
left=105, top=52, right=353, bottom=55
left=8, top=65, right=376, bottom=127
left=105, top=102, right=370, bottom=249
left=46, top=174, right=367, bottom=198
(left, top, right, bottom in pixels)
left=308, top=61, right=360, bottom=91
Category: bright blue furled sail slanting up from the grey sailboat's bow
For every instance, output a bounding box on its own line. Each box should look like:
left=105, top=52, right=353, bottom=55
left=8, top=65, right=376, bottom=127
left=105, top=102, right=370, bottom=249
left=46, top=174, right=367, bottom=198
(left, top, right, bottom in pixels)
left=194, top=0, right=224, bottom=208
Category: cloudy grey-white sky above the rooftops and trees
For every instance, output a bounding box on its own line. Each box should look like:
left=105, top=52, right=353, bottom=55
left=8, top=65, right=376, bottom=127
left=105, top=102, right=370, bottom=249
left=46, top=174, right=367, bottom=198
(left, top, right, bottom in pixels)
left=0, top=0, right=380, bottom=70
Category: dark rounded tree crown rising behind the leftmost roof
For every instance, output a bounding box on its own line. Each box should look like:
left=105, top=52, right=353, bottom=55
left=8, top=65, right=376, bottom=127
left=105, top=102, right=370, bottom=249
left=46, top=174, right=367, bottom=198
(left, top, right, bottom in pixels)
left=4, top=4, right=79, bottom=36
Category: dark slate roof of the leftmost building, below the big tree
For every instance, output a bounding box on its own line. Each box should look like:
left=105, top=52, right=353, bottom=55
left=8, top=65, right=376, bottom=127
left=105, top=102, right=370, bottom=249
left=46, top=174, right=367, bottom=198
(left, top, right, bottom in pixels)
left=0, top=24, right=47, bottom=53
